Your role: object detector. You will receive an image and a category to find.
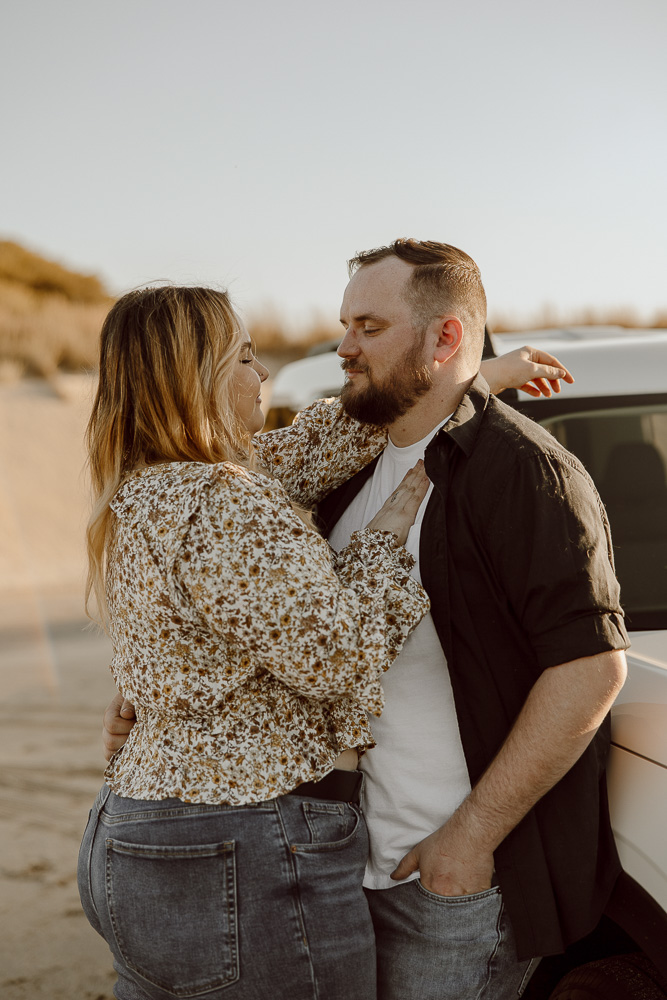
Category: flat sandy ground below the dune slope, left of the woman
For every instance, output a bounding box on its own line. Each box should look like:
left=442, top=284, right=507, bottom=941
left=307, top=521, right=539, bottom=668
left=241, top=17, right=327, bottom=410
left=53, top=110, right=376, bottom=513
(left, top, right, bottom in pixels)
left=0, top=592, right=115, bottom=1000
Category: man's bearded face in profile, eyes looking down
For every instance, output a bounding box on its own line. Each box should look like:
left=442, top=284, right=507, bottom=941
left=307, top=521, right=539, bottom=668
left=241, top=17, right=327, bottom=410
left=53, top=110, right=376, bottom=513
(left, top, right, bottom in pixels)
left=338, top=257, right=432, bottom=425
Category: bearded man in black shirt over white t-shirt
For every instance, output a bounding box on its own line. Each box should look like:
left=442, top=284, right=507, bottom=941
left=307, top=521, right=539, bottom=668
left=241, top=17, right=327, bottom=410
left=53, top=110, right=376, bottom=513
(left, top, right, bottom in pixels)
left=105, top=240, right=628, bottom=1000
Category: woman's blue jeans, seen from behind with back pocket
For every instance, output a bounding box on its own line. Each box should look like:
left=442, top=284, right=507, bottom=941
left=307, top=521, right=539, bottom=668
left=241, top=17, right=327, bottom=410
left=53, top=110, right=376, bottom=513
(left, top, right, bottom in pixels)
left=78, top=786, right=375, bottom=1000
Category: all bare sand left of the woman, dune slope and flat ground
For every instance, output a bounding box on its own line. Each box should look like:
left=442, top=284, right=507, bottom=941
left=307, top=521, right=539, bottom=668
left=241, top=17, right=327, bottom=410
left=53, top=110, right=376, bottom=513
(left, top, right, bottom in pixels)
left=0, top=364, right=290, bottom=1000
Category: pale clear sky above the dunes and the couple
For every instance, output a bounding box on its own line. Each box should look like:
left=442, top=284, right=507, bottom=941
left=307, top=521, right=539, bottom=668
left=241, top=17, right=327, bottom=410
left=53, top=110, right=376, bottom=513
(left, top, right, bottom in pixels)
left=0, top=0, right=667, bottom=326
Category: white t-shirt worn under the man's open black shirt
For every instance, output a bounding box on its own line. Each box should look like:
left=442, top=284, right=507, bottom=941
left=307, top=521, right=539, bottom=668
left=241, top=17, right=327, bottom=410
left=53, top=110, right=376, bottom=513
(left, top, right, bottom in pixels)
left=329, top=421, right=470, bottom=889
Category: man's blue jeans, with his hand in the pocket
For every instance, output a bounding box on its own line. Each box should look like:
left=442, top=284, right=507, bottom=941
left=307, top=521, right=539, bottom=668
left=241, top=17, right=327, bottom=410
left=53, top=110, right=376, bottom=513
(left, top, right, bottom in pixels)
left=366, top=879, right=539, bottom=1000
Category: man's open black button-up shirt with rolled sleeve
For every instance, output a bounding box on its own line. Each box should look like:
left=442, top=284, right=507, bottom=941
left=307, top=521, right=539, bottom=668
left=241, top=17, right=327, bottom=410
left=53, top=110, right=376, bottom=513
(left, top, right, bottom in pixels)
left=319, top=376, right=629, bottom=958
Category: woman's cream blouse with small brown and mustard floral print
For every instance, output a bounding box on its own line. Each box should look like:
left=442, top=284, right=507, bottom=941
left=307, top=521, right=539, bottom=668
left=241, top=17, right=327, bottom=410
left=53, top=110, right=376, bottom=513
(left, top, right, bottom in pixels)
left=105, top=402, right=428, bottom=805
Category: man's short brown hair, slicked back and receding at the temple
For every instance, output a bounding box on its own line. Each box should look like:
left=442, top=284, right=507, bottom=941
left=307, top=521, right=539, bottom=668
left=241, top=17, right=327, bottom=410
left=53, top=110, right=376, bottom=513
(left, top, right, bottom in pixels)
left=347, top=238, right=486, bottom=353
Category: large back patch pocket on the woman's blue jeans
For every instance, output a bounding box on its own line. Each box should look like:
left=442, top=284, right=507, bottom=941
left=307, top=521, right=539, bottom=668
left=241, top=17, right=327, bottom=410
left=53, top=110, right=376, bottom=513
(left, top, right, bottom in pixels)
left=106, top=839, right=239, bottom=997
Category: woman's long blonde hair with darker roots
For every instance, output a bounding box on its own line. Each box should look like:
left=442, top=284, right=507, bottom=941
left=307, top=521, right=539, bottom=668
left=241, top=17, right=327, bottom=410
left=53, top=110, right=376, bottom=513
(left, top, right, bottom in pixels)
left=86, top=286, right=252, bottom=621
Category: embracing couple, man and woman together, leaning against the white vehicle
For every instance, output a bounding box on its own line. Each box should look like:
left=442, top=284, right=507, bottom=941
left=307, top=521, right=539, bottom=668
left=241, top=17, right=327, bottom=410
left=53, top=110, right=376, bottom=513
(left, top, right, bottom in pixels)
left=79, top=239, right=628, bottom=1000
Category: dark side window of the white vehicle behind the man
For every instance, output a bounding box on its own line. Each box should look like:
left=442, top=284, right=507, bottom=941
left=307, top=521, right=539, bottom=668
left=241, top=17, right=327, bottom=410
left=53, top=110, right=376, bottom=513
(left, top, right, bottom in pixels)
left=540, top=404, right=667, bottom=629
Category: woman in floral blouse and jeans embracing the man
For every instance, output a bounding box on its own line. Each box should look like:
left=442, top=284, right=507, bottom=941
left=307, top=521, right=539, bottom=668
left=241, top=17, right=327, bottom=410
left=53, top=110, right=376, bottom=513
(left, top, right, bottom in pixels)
left=79, top=288, right=568, bottom=1000
